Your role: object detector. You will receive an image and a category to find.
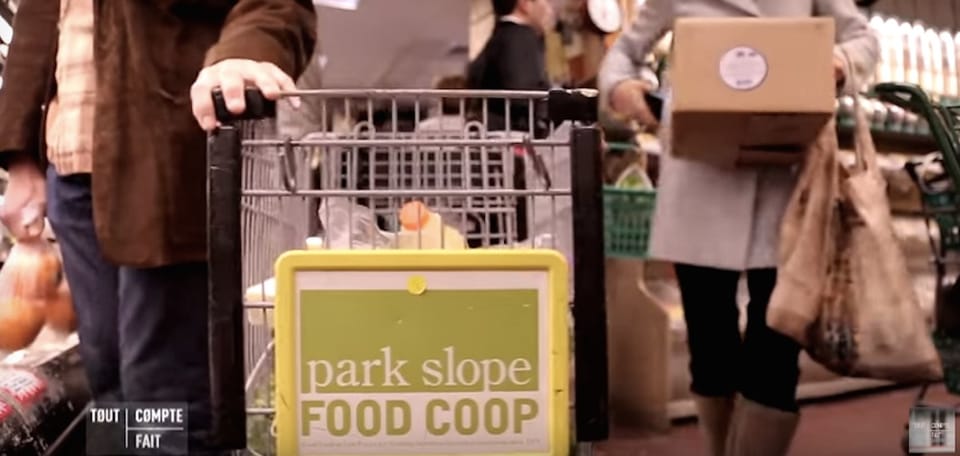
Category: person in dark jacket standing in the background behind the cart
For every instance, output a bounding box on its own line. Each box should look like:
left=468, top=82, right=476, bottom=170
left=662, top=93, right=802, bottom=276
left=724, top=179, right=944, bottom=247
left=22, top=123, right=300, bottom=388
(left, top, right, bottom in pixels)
left=467, top=0, right=556, bottom=136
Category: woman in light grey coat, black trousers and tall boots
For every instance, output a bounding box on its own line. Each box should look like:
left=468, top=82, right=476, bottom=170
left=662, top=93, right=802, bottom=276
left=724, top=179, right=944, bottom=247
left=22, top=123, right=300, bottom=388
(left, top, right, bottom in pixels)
left=599, top=0, right=878, bottom=456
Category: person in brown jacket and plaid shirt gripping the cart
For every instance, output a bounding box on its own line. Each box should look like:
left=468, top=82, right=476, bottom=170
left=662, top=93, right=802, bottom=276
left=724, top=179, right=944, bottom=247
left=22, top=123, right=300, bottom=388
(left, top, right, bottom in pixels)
left=0, top=0, right=316, bottom=454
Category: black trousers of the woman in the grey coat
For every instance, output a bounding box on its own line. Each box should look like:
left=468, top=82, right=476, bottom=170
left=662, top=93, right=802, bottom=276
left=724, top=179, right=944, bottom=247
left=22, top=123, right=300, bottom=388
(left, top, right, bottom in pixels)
left=675, top=264, right=800, bottom=412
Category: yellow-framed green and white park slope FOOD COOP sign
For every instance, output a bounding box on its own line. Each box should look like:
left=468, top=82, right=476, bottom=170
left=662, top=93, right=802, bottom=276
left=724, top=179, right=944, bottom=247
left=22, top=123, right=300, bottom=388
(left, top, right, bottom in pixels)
left=276, top=252, right=569, bottom=455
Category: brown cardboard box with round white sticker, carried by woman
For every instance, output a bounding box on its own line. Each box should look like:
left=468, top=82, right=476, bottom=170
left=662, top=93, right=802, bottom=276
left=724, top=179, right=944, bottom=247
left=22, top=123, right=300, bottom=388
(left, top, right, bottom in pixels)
left=670, top=18, right=836, bottom=166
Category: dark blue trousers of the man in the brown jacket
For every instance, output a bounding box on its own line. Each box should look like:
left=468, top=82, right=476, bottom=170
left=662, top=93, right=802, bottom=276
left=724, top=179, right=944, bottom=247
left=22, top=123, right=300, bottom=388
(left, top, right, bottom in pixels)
left=47, top=167, right=216, bottom=454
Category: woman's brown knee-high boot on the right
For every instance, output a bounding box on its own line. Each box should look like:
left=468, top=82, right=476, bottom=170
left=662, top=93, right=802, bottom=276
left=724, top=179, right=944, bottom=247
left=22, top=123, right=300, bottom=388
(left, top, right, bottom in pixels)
left=724, top=397, right=800, bottom=456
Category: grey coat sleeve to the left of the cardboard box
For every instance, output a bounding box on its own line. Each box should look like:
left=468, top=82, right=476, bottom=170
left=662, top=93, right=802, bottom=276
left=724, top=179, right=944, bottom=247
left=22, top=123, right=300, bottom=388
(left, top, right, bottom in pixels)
left=597, top=0, right=673, bottom=105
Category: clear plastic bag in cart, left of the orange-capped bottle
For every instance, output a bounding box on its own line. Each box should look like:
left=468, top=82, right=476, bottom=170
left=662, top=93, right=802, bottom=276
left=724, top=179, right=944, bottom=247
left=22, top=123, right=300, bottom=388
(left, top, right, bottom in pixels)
left=318, top=198, right=396, bottom=249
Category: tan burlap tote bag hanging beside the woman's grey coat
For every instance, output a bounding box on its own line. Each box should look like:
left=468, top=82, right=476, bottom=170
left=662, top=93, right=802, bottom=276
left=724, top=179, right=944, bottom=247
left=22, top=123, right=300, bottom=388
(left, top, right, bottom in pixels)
left=767, top=100, right=942, bottom=382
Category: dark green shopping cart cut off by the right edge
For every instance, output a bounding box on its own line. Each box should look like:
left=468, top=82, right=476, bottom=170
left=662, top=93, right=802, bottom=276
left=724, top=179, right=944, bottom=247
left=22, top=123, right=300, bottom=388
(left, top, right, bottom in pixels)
left=874, top=83, right=960, bottom=452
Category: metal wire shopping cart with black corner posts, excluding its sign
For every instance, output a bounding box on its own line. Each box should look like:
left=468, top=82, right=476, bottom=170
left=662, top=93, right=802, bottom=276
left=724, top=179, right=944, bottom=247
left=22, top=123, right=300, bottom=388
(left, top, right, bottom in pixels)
left=208, top=90, right=609, bottom=454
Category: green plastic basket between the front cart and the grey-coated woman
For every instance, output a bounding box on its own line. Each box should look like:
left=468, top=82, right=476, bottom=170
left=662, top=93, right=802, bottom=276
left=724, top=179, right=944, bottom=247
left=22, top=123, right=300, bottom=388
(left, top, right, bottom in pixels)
left=603, top=187, right=657, bottom=258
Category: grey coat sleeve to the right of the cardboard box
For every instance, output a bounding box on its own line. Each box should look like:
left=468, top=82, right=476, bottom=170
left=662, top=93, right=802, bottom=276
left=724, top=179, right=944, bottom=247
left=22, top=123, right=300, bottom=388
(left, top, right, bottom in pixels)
left=814, top=0, right=880, bottom=94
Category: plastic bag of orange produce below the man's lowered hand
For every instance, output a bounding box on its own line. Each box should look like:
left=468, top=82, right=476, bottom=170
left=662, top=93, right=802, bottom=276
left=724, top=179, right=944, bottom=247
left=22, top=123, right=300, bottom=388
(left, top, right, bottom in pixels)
left=0, top=237, right=76, bottom=350
